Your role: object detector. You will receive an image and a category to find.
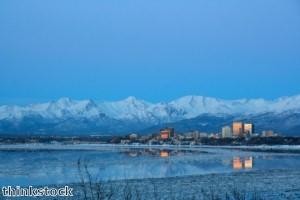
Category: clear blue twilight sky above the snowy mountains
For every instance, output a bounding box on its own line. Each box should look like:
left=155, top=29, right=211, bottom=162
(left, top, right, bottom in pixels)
left=0, top=0, right=300, bottom=103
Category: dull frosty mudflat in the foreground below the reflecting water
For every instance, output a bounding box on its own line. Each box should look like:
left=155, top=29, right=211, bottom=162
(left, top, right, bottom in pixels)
left=67, top=170, right=300, bottom=200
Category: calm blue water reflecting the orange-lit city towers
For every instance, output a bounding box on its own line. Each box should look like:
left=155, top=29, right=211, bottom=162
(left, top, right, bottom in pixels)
left=0, top=147, right=300, bottom=185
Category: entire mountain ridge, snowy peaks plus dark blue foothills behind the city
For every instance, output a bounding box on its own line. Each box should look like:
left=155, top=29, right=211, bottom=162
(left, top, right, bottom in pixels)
left=0, top=95, right=300, bottom=134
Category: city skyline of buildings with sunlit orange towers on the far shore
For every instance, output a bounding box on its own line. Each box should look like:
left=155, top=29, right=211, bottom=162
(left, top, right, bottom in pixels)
left=116, top=121, right=278, bottom=145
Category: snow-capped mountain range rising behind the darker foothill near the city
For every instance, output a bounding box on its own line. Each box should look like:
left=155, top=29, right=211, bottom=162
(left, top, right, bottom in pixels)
left=0, top=95, right=300, bottom=135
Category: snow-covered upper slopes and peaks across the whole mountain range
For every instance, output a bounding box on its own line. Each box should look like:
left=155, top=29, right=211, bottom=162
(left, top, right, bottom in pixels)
left=0, top=95, right=300, bottom=124
